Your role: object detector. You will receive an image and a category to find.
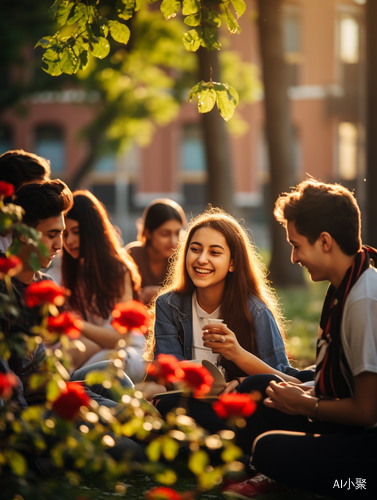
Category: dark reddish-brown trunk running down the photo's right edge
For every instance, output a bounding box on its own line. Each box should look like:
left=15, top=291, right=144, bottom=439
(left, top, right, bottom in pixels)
left=364, top=0, right=377, bottom=248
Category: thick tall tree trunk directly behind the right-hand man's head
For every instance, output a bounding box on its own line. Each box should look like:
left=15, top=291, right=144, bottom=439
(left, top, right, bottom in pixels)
left=258, top=0, right=304, bottom=286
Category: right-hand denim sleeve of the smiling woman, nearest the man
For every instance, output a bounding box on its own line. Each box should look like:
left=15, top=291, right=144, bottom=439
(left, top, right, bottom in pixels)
left=252, top=307, right=298, bottom=376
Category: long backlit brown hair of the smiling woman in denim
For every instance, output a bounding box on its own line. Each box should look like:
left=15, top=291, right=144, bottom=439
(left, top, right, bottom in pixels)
left=147, top=207, right=284, bottom=380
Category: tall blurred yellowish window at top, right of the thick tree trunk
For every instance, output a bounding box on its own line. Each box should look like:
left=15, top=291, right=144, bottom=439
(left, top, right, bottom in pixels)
left=283, top=5, right=302, bottom=87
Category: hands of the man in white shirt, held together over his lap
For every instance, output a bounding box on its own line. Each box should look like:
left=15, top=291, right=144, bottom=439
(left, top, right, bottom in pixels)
left=263, top=380, right=317, bottom=415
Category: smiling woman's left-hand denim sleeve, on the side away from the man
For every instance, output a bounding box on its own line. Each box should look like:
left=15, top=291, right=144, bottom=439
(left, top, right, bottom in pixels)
left=154, top=297, right=185, bottom=361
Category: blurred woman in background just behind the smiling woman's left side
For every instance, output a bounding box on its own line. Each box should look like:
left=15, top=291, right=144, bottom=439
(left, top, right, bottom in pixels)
left=126, top=198, right=187, bottom=304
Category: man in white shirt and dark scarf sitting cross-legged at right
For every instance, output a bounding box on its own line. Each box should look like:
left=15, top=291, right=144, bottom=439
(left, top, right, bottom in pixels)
left=220, top=179, right=377, bottom=500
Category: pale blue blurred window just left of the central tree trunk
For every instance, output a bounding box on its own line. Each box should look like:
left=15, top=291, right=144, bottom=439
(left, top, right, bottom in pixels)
left=181, top=124, right=206, bottom=172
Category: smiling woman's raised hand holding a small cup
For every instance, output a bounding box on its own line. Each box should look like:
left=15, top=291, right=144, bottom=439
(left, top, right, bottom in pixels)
left=202, top=323, right=243, bottom=361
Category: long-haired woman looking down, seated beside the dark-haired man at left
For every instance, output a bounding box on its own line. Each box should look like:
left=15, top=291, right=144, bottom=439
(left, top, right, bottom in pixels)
left=62, top=191, right=144, bottom=382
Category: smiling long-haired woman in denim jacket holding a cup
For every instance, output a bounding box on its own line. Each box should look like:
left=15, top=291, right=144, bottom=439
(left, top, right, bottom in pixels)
left=149, top=205, right=312, bottom=386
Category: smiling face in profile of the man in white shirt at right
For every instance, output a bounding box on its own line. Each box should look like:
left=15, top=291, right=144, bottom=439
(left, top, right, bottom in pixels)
left=287, top=222, right=329, bottom=281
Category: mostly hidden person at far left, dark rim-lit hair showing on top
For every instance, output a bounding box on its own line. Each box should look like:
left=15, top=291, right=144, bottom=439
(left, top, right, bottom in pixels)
left=0, top=149, right=51, bottom=253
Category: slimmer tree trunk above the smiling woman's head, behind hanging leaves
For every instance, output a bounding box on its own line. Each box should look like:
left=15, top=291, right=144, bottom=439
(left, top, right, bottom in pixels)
left=198, top=47, right=234, bottom=215
